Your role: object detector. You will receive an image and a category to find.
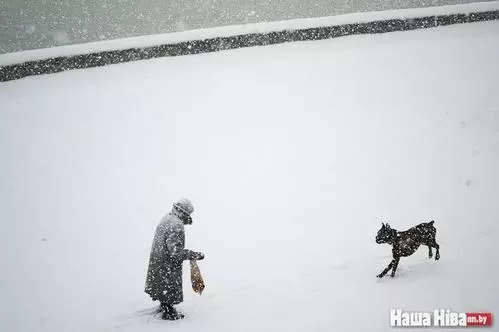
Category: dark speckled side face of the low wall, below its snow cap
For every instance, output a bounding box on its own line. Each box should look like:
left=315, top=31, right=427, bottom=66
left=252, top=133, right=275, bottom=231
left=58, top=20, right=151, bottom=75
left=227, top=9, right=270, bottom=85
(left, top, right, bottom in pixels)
left=0, top=10, right=499, bottom=82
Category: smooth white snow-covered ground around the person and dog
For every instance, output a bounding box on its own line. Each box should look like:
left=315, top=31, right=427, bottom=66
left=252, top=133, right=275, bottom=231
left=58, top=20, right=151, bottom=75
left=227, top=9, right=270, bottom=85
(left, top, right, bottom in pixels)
left=0, top=22, right=499, bottom=332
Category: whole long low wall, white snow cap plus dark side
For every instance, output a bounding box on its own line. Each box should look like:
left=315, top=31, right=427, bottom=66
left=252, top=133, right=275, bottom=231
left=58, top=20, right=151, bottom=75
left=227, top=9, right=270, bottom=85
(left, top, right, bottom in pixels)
left=0, top=1, right=499, bottom=82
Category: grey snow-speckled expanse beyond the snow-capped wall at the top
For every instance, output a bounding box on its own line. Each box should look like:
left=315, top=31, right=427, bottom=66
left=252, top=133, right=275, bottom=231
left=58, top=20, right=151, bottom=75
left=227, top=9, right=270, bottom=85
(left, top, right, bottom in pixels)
left=0, top=0, right=494, bottom=53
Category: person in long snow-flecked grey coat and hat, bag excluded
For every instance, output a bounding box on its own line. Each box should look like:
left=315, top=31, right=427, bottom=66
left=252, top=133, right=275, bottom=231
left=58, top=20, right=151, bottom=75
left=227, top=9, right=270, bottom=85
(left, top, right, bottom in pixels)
left=145, top=198, right=204, bottom=320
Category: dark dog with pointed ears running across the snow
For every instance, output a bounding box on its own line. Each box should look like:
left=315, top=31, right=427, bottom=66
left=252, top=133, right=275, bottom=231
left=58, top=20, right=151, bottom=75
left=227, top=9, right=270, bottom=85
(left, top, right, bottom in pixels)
left=376, top=220, right=440, bottom=278
